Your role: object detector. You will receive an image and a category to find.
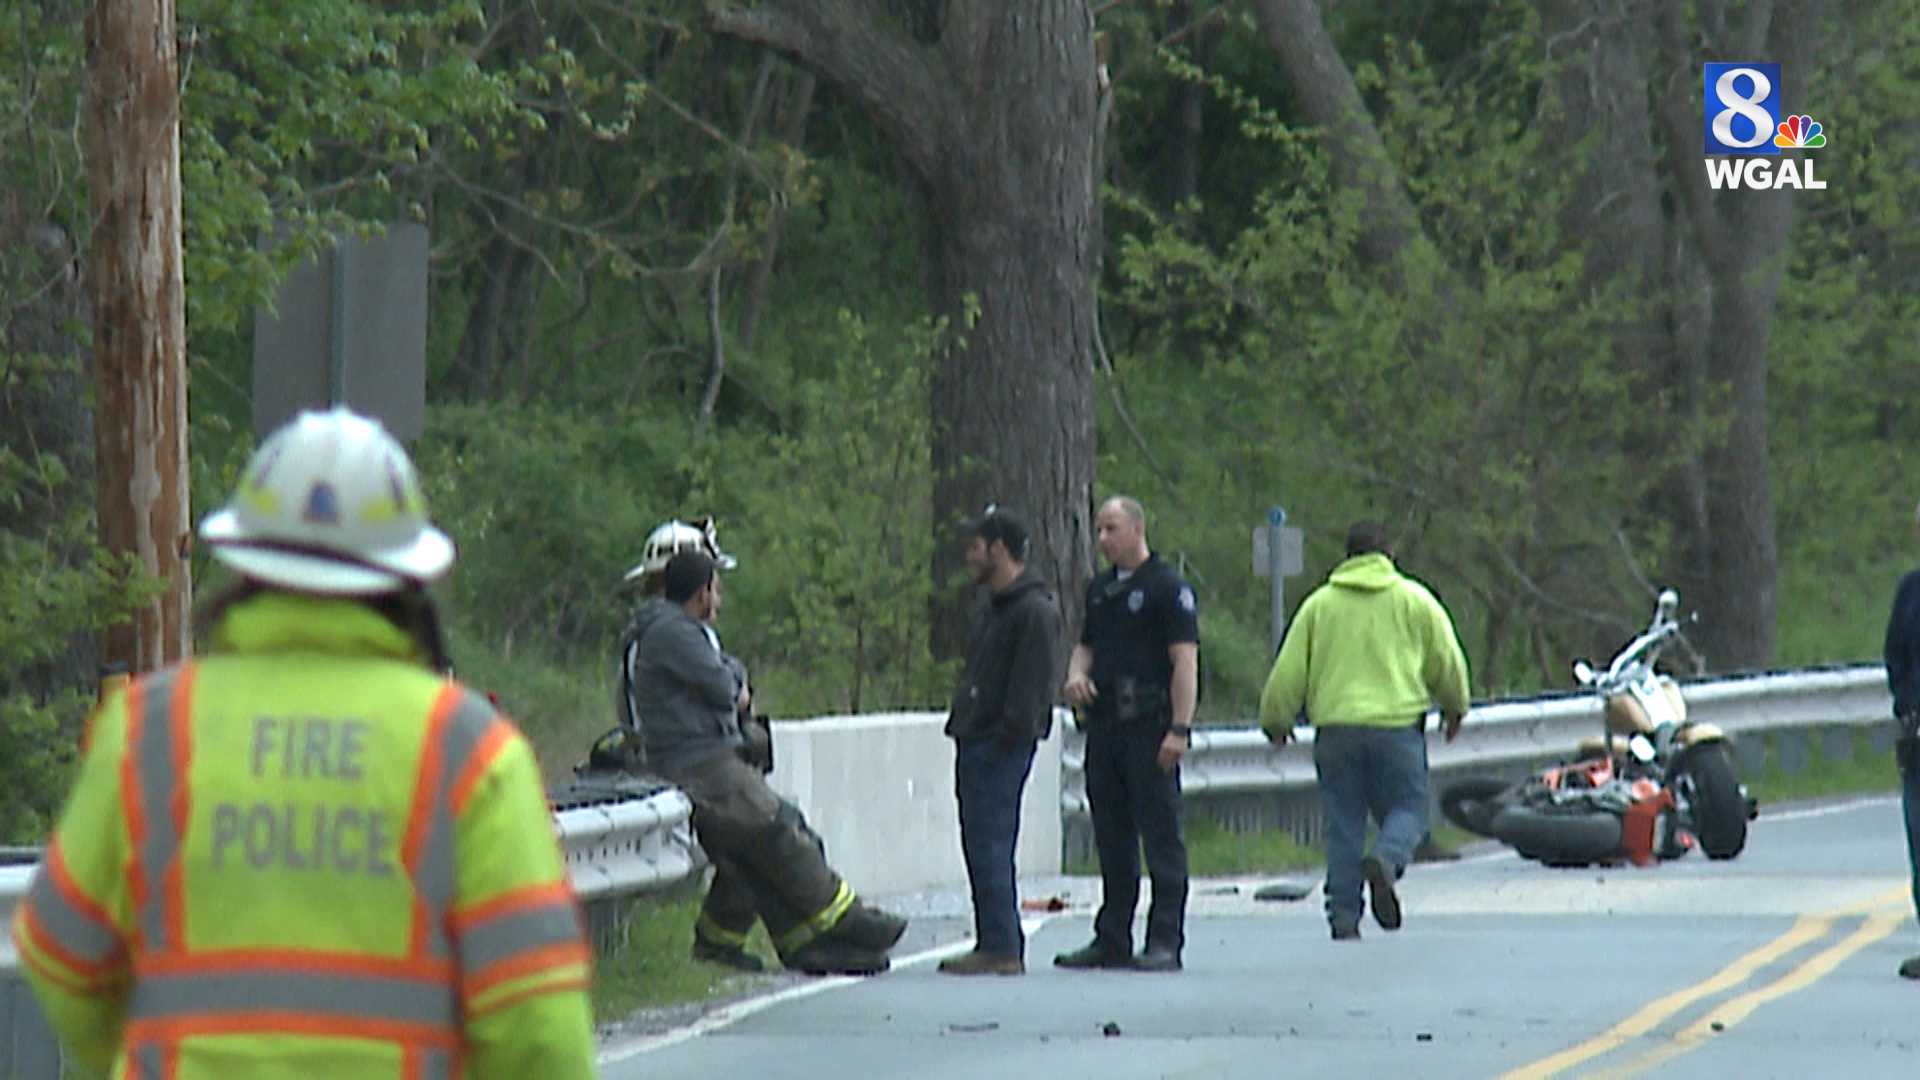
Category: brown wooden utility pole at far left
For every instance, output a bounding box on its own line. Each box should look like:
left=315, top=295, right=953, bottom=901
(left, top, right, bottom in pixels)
left=86, top=0, right=192, bottom=673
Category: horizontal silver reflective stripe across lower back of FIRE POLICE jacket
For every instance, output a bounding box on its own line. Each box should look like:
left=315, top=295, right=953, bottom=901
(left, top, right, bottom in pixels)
left=127, top=970, right=459, bottom=1030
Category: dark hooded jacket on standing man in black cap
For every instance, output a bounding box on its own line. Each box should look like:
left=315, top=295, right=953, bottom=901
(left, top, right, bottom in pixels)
left=947, top=571, right=1064, bottom=744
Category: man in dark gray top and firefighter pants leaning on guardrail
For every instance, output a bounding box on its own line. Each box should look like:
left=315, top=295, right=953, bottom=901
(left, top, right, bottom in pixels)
left=632, top=552, right=906, bottom=974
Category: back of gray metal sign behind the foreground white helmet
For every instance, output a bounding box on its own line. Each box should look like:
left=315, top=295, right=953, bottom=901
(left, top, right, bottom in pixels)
left=253, top=223, right=426, bottom=438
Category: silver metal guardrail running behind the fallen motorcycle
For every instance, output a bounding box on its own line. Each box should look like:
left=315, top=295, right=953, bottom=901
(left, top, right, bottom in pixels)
left=1060, top=665, right=1893, bottom=857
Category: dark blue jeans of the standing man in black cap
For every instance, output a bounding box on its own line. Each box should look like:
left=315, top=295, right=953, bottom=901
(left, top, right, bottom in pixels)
left=954, top=738, right=1035, bottom=957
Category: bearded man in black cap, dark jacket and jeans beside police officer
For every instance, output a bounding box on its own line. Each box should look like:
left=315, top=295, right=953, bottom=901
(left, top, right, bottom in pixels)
left=941, top=505, right=1062, bottom=974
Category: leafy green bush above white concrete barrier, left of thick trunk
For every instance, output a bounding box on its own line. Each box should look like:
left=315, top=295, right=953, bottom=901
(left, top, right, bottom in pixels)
left=712, top=311, right=950, bottom=715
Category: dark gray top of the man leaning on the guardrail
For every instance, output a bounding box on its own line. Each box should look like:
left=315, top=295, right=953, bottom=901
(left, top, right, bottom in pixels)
left=626, top=598, right=741, bottom=778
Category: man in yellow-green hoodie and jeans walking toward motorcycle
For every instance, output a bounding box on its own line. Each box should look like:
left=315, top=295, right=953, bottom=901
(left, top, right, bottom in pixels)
left=1260, top=521, right=1467, bottom=942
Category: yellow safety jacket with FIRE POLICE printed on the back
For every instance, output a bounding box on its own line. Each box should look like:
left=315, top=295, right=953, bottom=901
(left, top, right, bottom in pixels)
left=13, top=592, right=593, bottom=1080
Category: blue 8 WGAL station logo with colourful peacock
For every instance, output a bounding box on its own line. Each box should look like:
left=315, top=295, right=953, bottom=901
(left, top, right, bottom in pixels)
left=1701, top=63, right=1826, bottom=190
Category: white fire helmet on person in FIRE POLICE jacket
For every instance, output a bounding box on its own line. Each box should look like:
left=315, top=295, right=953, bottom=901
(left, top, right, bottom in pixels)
left=200, top=407, right=453, bottom=596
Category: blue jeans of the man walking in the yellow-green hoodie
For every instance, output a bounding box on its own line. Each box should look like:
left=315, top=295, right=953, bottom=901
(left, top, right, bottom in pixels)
left=1313, top=724, right=1428, bottom=926
